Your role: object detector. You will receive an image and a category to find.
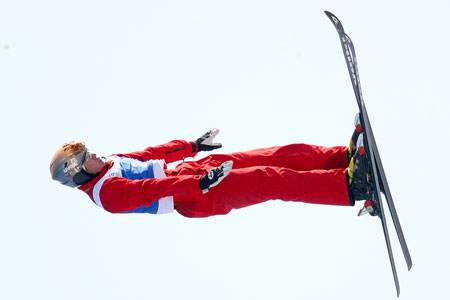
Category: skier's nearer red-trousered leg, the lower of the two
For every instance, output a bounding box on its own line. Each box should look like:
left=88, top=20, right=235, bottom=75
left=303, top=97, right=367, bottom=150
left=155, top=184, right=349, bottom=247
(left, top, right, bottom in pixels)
left=175, top=166, right=351, bottom=217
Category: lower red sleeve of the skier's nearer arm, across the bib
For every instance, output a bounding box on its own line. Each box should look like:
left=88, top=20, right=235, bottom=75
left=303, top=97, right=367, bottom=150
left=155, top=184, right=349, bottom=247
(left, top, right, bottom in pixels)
left=100, top=175, right=202, bottom=213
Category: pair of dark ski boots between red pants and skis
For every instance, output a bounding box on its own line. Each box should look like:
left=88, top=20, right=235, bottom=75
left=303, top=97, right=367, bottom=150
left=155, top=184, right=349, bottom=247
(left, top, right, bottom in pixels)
left=347, top=133, right=379, bottom=216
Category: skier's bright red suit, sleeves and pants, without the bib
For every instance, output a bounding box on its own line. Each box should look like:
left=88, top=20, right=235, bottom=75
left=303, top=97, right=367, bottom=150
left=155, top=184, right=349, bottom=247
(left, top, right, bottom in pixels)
left=80, top=140, right=351, bottom=217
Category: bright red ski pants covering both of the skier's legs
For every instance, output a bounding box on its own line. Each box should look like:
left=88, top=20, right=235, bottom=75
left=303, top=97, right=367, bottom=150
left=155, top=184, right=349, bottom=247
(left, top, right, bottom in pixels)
left=168, top=144, right=351, bottom=218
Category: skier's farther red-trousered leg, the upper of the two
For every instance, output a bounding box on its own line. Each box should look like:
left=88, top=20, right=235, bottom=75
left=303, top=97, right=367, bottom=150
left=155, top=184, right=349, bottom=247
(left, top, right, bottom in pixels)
left=197, top=144, right=349, bottom=171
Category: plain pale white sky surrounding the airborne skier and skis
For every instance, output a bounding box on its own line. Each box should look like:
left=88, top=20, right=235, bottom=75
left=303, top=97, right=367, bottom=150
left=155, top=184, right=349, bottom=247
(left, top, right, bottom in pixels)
left=0, top=0, right=450, bottom=300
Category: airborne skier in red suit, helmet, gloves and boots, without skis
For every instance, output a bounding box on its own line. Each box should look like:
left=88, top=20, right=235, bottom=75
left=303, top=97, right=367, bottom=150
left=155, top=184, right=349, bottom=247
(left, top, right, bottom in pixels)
left=50, top=115, right=372, bottom=218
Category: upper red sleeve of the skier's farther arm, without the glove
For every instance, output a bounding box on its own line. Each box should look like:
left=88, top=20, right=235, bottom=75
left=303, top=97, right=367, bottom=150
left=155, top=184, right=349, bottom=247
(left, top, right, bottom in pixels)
left=115, top=140, right=197, bottom=163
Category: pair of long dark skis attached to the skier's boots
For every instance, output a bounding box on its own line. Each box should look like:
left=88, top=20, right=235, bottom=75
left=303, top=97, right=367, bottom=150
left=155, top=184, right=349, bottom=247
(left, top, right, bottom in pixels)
left=325, top=11, right=412, bottom=297
